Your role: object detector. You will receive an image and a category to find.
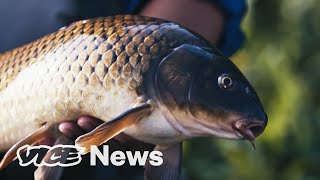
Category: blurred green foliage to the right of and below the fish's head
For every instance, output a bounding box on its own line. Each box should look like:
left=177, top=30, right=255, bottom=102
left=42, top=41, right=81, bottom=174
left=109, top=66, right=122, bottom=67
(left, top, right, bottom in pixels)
left=184, top=0, right=320, bottom=180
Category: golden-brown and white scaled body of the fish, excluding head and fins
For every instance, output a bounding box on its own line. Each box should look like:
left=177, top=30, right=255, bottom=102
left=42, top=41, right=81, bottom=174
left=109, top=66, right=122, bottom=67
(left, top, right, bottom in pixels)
left=0, top=15, right=206, bottom=150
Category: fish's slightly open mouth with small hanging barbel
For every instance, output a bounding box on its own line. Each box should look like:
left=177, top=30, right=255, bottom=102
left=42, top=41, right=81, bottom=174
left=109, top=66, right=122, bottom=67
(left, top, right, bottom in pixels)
left=232, top=118, right=266, bottom=149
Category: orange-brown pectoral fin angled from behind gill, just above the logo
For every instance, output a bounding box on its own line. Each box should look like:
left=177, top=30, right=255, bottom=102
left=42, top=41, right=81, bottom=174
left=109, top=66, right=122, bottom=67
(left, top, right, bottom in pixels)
left=75, top=102, right=152, bottom=154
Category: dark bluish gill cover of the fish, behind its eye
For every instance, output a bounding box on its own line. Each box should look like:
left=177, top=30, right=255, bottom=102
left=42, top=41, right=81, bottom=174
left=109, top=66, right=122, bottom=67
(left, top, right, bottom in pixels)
left=154, top=44, right=213, bottom=106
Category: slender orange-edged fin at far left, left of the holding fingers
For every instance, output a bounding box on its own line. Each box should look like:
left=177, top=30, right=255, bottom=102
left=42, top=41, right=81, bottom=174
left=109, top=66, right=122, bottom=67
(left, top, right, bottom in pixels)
left=0, top=125, right=52, bottom=170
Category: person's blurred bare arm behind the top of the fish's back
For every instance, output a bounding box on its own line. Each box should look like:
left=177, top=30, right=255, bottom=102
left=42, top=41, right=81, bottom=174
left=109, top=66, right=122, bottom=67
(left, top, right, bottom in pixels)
left=139, top=0, right=224, bottom=44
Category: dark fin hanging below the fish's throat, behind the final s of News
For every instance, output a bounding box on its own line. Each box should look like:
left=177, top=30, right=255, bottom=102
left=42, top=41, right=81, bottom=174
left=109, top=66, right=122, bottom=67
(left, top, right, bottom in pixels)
left=144, top=142, right=182, bottom=180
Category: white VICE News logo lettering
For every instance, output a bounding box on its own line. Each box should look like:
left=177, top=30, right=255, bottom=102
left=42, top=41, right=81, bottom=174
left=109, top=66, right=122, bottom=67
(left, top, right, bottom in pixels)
left=17, top=145, right=163, bottom=167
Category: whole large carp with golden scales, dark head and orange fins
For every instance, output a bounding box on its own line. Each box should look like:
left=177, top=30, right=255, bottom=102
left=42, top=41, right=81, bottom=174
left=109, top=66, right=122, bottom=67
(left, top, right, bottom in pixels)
left=0, top=15, right=267, bottom=179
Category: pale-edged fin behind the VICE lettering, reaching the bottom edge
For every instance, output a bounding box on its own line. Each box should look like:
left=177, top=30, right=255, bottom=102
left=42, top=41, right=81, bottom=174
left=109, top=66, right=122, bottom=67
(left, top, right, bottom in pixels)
left=34, top=134, right=73, bottom=180
